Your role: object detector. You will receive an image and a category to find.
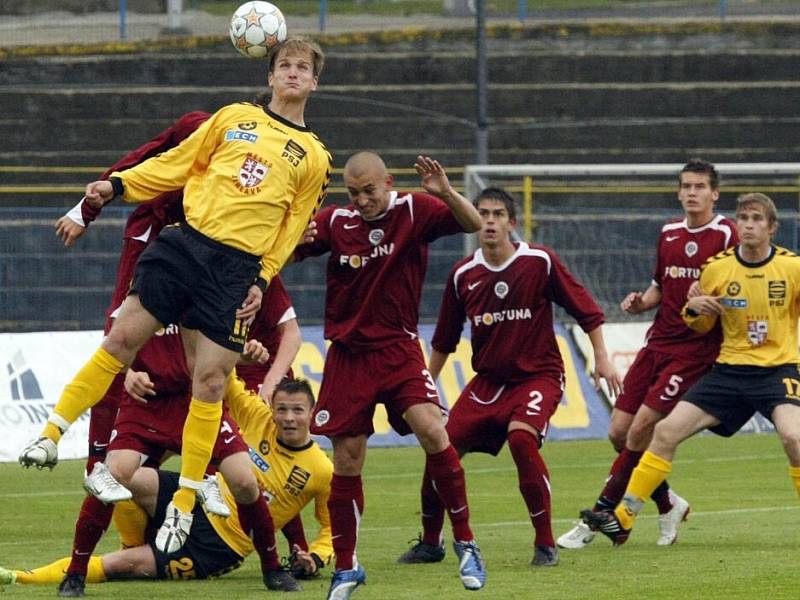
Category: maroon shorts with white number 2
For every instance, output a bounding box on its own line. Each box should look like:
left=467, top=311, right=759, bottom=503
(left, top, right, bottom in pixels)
left=447, top=375, right=564, bottom=456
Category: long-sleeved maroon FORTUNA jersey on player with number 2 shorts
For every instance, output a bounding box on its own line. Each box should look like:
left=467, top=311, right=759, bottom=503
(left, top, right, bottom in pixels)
left=431, top=243, right=605, bottom=383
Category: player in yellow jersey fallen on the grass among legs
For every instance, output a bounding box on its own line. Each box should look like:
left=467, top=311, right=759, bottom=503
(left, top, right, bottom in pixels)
left=0, top=379, right=333, bottom=585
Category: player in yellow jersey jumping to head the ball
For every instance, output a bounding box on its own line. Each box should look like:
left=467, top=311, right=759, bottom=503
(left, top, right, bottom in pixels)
left=19, top=39, right=331, bottom=552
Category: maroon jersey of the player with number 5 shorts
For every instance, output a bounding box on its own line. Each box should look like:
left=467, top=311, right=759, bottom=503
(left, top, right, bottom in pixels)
left=646, top=215, right=739, bottom=360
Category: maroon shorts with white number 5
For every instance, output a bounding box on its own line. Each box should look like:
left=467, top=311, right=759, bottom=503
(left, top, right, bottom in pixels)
left=614, top=347, right=712, bottom=415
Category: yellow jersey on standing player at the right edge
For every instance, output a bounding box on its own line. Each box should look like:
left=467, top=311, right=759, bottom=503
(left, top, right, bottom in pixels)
left=682, top=246, right=800, bottom=367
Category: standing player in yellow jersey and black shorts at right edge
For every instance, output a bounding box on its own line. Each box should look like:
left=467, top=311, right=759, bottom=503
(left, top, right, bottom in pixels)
left=592, top=193, right=800, bottom=545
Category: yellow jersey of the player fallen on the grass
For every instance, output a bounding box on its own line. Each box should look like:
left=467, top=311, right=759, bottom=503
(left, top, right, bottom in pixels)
left=206, top=380, right=333, bottom=564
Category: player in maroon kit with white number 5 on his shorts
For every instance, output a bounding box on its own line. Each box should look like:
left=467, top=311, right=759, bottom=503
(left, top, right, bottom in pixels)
left=558, top=158, right=738, bottom=549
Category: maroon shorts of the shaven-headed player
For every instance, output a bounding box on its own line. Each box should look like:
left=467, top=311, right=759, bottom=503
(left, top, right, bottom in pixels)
left=311, top=340, right=444, bottom=437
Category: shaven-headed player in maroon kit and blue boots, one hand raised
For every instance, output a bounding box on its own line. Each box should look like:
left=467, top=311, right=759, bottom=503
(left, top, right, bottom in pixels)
left=295, top=152, right=485, bottom=599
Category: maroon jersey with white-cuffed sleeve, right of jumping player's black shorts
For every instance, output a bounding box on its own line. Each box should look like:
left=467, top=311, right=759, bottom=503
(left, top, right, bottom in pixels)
left=241, top=275, right=297, bottom=390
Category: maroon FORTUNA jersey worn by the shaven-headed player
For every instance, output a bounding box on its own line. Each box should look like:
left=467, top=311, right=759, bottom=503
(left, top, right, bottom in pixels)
left=295, top=192, right=464, bottom=352
